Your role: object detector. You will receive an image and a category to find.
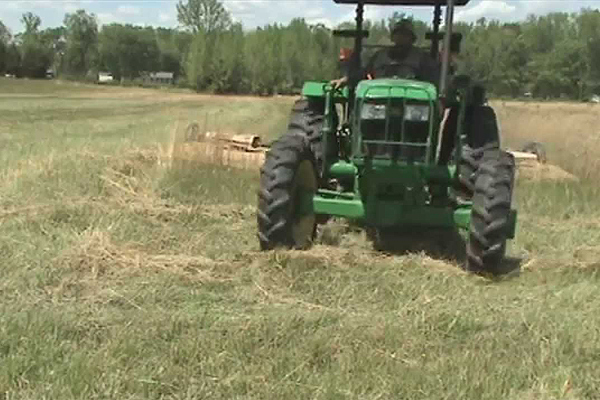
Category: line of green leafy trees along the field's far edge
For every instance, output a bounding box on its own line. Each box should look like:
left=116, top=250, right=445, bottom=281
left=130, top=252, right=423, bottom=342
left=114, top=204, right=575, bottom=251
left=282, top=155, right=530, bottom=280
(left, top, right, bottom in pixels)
left=0, top=0, right=600, bottom=100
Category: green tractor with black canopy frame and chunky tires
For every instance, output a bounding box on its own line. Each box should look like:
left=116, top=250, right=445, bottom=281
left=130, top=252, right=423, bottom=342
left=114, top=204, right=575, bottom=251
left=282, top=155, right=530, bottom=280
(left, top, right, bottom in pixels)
left=257, top=0, right=517, bottom=274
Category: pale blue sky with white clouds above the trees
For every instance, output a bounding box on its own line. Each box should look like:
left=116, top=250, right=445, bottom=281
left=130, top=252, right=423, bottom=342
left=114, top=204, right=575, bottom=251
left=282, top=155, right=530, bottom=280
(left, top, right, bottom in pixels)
left=0, top=0, right=600, bottom=34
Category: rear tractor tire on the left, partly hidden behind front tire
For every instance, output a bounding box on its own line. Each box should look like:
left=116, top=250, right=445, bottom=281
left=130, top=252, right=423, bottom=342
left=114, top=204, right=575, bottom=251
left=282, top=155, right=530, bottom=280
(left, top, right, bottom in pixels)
left=288, top=99, right=325, bottom=179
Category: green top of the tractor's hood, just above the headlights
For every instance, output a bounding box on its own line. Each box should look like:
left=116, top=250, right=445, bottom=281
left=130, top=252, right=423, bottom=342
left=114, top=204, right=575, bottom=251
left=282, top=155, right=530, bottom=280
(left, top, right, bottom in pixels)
left=356, top=79, right=437, bottom=101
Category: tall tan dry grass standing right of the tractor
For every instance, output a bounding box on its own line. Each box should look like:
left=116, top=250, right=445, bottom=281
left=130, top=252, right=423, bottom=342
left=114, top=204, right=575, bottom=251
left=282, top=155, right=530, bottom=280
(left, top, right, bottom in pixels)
left=492, top=101, right=600, bottom=180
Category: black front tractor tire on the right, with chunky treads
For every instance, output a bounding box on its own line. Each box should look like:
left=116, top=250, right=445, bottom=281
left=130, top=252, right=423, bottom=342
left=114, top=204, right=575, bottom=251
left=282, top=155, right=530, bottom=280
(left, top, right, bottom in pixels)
left=467, top=151, right=515, bottom=275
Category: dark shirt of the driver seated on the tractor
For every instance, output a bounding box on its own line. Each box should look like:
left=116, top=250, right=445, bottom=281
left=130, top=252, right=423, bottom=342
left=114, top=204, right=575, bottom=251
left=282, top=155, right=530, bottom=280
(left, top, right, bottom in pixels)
left=365, top=46, right=438, bottom=83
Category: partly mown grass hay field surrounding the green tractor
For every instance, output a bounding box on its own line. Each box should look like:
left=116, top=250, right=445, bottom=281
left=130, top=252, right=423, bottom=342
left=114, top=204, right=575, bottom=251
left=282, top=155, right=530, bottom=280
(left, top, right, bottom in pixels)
left=0, top=80, right=600, bottom=400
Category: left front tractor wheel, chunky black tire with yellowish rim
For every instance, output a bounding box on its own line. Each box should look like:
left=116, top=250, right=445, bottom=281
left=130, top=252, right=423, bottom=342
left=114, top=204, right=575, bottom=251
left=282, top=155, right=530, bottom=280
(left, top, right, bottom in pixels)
left=257, top=132, right=318, bottom=250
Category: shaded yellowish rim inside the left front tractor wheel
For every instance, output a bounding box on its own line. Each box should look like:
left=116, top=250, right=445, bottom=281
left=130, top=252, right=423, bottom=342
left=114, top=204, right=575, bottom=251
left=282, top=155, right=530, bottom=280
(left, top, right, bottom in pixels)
left=291, top=160, right=317, bottom=248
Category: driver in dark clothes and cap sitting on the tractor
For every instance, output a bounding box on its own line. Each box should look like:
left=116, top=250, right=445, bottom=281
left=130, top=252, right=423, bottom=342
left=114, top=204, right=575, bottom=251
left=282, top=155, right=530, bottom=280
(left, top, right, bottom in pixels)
left=331, top=19, right=439, bottom=88
